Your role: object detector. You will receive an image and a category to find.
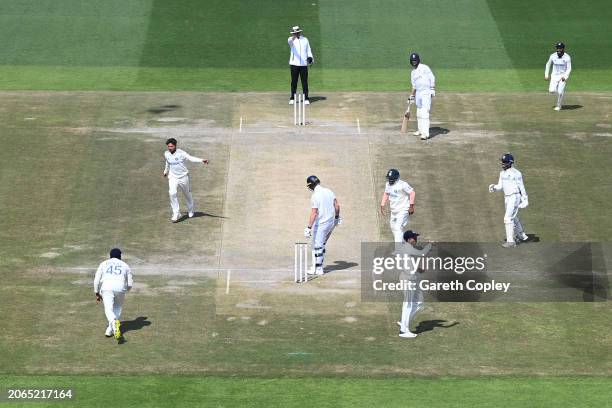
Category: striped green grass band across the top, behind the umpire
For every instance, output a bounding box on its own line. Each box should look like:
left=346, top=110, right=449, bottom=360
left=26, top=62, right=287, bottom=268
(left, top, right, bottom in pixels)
left=0, top=0, right=612, bottom=92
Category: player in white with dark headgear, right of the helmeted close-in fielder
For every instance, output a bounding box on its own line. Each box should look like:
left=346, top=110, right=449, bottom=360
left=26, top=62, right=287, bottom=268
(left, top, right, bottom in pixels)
left=489, top=153, right=529, bottom=248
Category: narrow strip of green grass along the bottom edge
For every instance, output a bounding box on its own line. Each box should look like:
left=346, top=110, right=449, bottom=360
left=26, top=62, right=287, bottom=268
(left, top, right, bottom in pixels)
left=0, top=375, right=612, bottom=408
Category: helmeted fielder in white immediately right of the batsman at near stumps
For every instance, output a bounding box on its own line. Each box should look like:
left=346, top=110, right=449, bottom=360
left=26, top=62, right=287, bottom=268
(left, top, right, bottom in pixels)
left=380, top=169, right=416, bottom=242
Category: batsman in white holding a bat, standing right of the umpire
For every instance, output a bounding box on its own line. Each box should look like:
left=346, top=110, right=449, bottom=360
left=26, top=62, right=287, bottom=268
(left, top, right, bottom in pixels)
left=410, top=52, right=436, bottom=140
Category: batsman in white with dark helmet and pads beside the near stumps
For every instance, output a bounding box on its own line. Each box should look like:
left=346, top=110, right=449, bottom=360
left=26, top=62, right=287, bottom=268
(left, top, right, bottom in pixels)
left=304, top=176, right=342, bottom=275
